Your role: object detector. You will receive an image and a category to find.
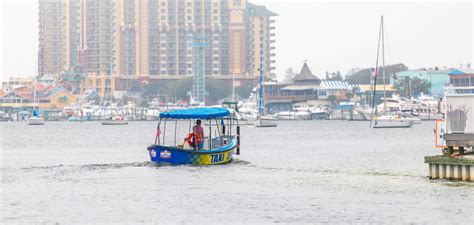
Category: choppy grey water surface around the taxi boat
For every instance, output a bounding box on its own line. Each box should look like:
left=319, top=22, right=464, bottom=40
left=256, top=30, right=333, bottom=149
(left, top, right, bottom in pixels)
left=0, top=121, right=474, bottom=224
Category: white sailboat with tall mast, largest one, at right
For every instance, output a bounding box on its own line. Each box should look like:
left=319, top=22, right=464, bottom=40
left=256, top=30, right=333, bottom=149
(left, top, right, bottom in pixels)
left=370, top=16, right=414, bottom=128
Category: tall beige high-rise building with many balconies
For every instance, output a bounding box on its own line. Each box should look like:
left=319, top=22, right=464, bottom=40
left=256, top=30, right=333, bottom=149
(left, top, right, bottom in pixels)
left=38, top=0, right=277, bottom=96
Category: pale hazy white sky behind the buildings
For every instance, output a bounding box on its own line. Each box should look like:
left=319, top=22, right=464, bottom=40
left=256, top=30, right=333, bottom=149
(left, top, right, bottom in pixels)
left=0, top=0, right=474, bottom=80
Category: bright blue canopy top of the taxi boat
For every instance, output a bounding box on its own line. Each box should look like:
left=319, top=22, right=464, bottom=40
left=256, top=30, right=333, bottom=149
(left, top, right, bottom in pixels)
left=160, top=108, right=230, bottom=119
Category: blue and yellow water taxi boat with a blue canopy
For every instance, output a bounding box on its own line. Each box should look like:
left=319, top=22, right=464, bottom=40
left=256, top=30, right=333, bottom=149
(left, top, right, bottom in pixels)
left=147, top=108, right=240, bottom=165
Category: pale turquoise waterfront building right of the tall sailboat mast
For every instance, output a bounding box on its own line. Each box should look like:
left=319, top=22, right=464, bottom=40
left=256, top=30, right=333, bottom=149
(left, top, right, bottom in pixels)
left=391, top=68, right=449, bottom=97
